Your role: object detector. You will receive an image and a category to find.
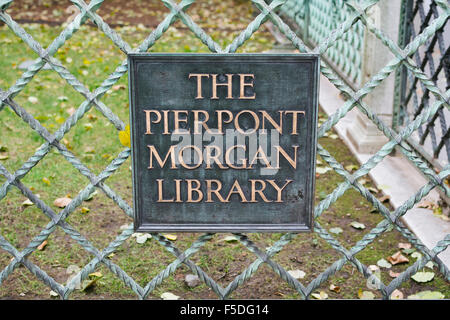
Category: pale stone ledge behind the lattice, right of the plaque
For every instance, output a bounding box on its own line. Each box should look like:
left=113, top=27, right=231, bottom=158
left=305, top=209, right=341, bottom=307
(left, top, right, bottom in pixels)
left=319, top=75, right=450, bottom=268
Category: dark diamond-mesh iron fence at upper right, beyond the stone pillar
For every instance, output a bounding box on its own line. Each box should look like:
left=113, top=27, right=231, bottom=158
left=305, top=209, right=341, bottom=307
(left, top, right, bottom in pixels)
left=393, top=0, right=450, bottom=169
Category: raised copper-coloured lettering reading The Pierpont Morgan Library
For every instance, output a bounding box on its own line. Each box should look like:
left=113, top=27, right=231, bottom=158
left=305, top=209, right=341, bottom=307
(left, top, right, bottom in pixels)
left=142, top=73, right=305, bottom=203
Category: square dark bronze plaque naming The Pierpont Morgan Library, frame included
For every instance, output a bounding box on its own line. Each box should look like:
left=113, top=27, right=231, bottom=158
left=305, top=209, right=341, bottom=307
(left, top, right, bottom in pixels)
left=128, top=53, right=319, bottom=232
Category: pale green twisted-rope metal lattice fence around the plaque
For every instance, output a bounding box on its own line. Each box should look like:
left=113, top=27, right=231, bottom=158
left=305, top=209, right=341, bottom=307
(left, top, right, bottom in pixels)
left=0, top=0, right=450, bottom=299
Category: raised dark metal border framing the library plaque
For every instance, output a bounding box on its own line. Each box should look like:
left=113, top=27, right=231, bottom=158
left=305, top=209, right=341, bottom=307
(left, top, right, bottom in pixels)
left=127, top=53, right=320, bottom=233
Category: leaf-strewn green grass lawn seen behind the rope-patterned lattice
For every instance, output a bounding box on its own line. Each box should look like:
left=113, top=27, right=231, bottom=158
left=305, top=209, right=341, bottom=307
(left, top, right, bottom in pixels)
left=0, top=0, right=450, bottom=299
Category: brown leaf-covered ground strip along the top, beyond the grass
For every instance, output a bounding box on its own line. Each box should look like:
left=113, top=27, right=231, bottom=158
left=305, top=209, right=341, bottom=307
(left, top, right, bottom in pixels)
left=0, top=0, right=254, bottom=31
